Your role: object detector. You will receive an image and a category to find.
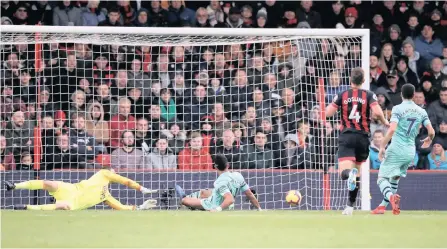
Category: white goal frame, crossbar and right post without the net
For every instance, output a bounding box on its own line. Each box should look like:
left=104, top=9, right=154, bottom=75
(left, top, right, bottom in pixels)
left=0, top=25, right=371, bottom=211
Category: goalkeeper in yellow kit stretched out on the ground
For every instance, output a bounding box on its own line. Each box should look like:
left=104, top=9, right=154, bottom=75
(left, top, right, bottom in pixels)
left=5, top=168, right=157, bottom=210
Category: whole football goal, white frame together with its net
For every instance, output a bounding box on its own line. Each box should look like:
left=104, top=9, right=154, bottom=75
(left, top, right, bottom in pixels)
left=0, top=25, right=370, bottom=210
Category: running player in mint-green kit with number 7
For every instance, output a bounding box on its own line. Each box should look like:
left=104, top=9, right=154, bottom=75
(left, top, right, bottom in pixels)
left=372, top=84, right=435, bottom=215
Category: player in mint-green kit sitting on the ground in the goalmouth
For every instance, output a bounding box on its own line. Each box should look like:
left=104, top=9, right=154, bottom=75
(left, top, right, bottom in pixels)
left=176, top=155, right=261, bottom=212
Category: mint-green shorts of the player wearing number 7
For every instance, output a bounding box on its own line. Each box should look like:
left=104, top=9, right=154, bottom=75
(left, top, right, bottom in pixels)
left=379, top=147, right=416, bottom=178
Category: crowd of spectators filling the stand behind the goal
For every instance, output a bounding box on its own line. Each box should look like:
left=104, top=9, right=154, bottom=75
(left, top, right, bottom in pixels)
left=0, top=0, right=447, bottom=170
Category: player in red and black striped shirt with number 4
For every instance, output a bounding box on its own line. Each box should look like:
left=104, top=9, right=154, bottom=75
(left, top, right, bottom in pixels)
left=326, top=68, right=389, bottom=215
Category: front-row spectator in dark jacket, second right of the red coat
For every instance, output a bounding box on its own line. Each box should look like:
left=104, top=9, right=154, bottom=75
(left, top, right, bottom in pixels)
left=247, top=130, right=275, bottom=169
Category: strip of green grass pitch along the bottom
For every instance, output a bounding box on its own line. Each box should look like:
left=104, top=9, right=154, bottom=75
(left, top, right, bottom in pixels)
left=1, top=210, right=447, bottom=248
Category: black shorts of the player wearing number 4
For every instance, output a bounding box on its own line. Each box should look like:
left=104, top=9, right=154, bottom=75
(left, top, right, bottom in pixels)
left=338, top=132, right=370, bottom=163
